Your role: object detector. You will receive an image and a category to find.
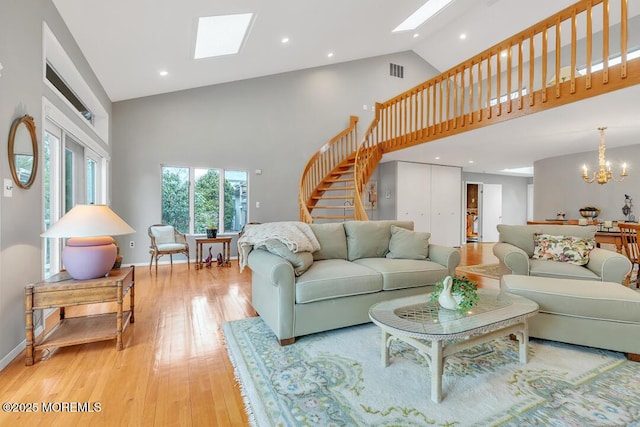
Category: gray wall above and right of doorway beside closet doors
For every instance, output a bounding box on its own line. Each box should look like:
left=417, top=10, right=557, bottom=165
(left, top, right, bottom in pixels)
left=462, top=172, right=530, bottom=224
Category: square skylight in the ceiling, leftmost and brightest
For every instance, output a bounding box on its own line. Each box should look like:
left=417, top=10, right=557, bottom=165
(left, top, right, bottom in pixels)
left=193, top=13, right=253, bottom=59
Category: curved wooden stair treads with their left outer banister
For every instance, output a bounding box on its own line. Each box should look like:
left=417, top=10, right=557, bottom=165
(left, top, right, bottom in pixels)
left=298, top=116, right=358, bottom=223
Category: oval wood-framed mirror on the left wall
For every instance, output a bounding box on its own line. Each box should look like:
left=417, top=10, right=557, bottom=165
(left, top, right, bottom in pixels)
left=9, top=115, right=38, bottom=189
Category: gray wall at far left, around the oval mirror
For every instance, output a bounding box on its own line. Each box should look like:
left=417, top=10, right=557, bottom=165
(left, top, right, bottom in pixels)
left=0, top=0, right=111, bottom=369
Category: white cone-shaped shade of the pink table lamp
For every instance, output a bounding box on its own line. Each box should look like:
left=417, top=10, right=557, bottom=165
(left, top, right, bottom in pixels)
left=41, top=205, right=135, bottom=237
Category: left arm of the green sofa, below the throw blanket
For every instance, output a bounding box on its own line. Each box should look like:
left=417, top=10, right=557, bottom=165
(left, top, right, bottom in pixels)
left=248, top=249, right=296, bottom=343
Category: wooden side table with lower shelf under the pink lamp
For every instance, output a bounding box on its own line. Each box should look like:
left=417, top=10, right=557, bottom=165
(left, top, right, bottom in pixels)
left=24, top=266, right=135, bottom=366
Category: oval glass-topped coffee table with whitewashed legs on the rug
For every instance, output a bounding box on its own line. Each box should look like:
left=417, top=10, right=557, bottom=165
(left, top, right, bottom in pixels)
left=369, top=289, right=538, bottom=403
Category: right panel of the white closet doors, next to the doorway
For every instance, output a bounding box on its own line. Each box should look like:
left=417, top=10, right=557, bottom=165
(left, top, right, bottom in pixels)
left=430, top=165, right=462, bottom=246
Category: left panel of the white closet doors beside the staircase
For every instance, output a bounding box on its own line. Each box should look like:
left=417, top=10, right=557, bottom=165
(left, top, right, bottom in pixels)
left=396, top=162, right=431, bottom=231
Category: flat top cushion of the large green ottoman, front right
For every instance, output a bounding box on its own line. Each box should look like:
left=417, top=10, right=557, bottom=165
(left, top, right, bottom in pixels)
left=500, top=274, right=640, bottom=323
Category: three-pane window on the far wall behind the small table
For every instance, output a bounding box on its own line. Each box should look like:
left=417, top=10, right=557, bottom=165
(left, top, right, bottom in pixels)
left=162, top=166, right=248, bottom=234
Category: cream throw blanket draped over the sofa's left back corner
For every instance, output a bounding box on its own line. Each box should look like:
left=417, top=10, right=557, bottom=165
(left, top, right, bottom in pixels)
left=238, top=221, right=320, bottom=271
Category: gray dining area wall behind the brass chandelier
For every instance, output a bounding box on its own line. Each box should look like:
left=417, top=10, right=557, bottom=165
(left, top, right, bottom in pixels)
left=534, top=145, right=640, bottom=221
